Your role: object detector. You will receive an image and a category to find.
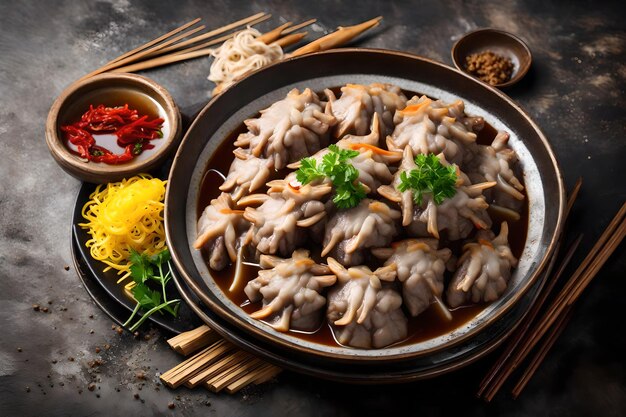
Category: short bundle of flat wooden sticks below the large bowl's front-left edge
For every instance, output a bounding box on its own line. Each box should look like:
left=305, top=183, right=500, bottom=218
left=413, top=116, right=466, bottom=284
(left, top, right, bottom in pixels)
left=160, top=325, right=281, bottom=394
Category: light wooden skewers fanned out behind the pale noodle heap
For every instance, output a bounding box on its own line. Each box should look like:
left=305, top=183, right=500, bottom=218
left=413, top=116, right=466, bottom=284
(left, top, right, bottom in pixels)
left=81, top=12, right=382, bottom=92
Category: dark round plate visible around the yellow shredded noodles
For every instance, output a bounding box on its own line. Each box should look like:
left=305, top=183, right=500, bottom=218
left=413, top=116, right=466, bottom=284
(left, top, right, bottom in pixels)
left=72, top=183, right=200, bottom=334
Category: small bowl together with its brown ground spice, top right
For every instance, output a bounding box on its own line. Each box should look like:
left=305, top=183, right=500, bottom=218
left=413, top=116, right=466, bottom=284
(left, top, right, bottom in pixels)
left=452, top=29, right=532, bottom=88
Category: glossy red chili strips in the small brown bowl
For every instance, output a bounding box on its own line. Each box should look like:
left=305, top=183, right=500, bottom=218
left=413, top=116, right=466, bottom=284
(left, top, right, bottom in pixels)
left=61, top=104, right=164, bottom=165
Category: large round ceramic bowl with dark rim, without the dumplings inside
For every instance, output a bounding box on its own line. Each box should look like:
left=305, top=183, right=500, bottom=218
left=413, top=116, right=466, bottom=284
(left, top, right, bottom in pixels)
left=165, top=49, right=564, bottom=366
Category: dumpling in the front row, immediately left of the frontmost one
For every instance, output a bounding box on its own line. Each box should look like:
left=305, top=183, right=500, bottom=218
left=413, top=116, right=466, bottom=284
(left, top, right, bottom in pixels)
left=244, top=249, right=337, bottom=332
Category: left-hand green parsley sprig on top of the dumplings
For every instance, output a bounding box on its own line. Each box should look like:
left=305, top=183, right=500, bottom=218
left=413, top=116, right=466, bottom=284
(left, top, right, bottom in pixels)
left=296, top=145, right=366, bottom=209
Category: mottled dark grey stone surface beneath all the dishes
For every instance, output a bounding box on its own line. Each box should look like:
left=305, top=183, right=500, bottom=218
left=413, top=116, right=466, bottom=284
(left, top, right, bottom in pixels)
left=0, top=0, right=626, bottom=416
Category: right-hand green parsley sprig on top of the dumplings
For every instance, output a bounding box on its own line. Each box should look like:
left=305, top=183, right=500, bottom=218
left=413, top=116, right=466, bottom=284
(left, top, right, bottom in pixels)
left=398, top=154, right=457, bottom=205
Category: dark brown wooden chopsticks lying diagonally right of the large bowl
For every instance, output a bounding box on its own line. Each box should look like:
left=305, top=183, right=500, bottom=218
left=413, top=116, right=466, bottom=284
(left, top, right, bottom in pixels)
left=477, top=179, right=626, bottom=401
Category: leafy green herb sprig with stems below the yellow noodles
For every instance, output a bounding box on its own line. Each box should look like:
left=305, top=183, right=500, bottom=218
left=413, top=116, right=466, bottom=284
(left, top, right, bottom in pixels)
left=124, top=249, right=180, bottom=332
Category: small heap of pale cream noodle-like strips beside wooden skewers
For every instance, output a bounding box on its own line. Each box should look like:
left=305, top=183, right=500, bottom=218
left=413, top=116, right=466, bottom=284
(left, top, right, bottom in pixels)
left=209, top=27, right=283, bottom=91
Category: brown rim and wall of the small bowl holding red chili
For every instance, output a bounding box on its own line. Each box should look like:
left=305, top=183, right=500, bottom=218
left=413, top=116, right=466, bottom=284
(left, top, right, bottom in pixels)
left=45, top=72, right=182, bottom=183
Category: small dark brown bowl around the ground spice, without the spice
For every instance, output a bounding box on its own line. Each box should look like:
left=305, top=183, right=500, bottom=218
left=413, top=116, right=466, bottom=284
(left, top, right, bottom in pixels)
left=452, top=29, right=532, bottom=88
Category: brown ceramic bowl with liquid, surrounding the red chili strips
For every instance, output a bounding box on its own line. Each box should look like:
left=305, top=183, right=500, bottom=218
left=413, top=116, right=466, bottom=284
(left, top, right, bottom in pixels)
left=46, top=73, right=182, bottom=183
